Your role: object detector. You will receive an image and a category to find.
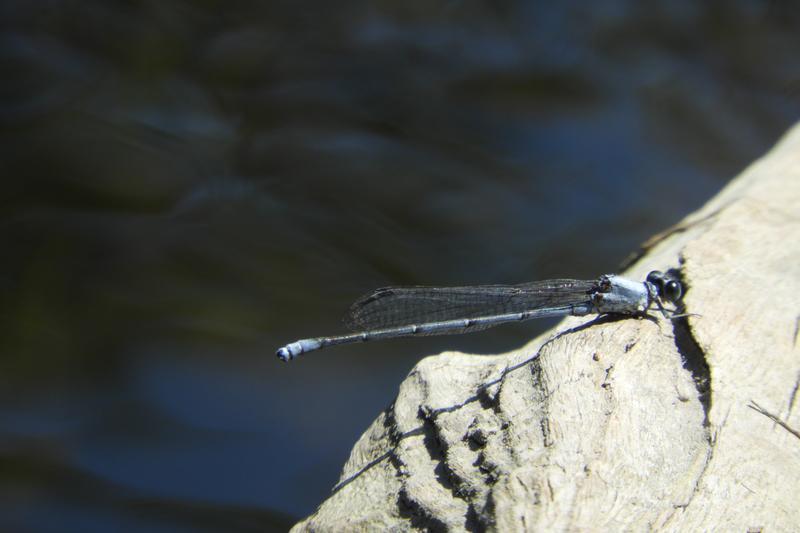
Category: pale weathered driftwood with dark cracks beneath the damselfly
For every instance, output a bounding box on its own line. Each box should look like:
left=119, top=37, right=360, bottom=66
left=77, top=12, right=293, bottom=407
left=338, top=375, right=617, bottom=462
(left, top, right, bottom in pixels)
left=295, top=122, right=800, bottom=531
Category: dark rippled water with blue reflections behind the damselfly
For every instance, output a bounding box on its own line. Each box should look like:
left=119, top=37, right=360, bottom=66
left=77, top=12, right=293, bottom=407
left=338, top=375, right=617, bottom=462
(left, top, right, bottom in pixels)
left=0, top=0, right=800, bottom=531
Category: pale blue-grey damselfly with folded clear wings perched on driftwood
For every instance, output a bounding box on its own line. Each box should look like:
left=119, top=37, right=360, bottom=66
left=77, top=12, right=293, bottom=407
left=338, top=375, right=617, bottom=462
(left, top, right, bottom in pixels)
left=277, top=270, right=683, bottom=361
